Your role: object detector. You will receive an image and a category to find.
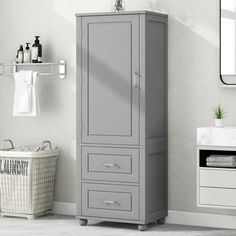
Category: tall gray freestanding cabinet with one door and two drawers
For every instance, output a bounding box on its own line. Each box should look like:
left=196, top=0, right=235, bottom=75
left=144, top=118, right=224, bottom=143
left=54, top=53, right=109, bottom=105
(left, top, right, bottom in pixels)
left=76, top=11, right=167, bottom=230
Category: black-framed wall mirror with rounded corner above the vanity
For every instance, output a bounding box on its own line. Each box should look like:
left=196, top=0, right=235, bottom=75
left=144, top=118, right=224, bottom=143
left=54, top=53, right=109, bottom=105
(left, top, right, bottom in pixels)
left=220, top=0, right=236, bottom=85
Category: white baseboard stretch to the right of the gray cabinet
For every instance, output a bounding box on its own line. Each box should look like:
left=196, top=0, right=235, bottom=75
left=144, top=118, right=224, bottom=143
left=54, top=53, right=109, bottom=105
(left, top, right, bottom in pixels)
left=166, top=210, right=236, bottom=229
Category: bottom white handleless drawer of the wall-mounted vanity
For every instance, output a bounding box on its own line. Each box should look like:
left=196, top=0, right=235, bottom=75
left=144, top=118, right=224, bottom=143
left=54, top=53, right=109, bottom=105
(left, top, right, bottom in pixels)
left=200, top=187, right=236, bottom=207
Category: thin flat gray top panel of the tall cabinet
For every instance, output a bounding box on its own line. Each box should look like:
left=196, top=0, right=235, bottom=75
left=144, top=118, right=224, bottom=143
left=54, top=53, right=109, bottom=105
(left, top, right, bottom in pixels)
left=75, top=11, right=168, bottom=17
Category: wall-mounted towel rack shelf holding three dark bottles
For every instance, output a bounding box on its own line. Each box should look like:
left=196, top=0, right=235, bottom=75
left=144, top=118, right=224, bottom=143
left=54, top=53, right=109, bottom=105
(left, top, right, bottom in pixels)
left=0, top=60, right=66, bottom=79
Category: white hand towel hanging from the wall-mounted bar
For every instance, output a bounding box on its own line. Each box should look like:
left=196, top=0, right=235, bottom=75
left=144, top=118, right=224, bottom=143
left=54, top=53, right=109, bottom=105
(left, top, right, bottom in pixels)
left=13, top=71, right=39, bottom=116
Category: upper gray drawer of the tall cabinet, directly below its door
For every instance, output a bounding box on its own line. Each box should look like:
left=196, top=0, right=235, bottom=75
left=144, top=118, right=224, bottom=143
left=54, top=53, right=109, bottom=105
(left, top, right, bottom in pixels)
left=82, top=147, right=139, bottom=182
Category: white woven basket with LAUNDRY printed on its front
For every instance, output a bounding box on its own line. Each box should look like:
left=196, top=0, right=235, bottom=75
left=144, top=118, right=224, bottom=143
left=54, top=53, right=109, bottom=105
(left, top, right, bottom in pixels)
left=0, top=140, right=59, bottom=219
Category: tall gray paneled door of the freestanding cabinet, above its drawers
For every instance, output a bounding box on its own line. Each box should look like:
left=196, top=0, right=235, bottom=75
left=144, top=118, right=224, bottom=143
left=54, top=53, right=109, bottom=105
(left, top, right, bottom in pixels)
left=81, top=15, right=139, bottom=144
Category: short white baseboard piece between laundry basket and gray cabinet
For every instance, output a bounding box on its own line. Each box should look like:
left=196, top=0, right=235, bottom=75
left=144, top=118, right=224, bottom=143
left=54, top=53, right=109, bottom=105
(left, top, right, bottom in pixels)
left=53, top=202, right=76, bottom=216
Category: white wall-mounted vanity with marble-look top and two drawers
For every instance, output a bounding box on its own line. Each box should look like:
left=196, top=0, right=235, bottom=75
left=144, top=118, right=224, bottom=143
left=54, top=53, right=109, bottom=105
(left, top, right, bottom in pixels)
left=197, top=127, right=236, bottom=209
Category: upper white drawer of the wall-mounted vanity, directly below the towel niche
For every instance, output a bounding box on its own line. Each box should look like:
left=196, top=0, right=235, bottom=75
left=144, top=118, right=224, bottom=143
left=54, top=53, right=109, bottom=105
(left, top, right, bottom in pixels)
left=199, top=170, right=236, bottom=188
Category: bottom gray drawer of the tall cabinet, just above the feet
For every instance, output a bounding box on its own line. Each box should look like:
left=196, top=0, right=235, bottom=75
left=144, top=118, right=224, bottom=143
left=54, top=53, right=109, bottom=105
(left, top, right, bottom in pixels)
left=82, top=184, right=139, bottom=220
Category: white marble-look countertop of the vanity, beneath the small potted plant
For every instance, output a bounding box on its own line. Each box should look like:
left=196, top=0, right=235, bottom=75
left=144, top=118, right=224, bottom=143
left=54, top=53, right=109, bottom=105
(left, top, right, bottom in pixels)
left=197, top=126, right=236, bottom=147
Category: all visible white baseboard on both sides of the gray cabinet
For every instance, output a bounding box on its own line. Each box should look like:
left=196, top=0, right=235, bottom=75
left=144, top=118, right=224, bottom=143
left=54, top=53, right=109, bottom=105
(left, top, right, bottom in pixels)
left=53, top=202, right=236, bottom=229
